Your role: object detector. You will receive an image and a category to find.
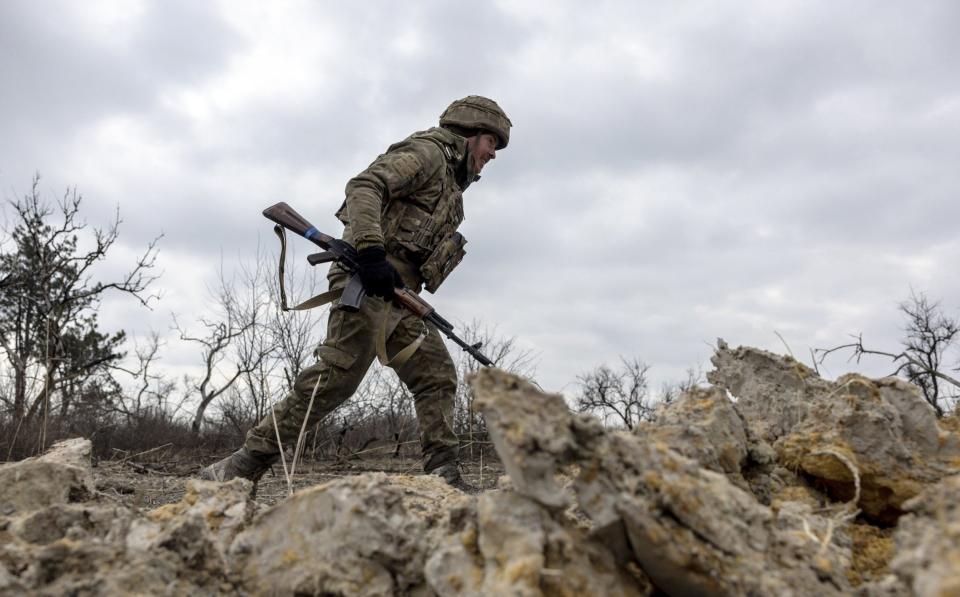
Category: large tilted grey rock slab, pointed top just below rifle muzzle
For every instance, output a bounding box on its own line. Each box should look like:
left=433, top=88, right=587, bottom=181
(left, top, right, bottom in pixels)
left=471, top=370, right=850, bottom=595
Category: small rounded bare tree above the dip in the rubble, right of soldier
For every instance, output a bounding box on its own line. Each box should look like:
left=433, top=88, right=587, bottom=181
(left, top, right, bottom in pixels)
left=576, top=357, right=656, bottom=429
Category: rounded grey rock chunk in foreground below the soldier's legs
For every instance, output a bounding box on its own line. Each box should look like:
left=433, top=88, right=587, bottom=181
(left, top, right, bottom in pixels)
left=230, top=473, right=472, bottom=595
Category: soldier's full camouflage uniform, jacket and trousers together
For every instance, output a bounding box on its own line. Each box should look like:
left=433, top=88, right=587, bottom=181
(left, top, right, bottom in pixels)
left=245, top=112, right=509, bottom=472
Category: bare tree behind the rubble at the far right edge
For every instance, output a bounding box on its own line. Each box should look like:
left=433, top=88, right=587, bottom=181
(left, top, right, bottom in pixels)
left=813, top=291, right=960, bottom=417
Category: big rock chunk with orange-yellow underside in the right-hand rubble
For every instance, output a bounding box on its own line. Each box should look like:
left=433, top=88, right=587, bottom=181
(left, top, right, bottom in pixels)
left=708, top=343, right=960, bottom=524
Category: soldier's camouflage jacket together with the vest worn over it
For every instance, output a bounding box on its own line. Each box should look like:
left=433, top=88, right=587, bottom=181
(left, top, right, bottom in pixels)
left=337, top=128, right=472, bottom=292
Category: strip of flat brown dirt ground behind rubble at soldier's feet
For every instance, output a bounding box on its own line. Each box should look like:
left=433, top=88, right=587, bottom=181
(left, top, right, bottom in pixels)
left=93, top=449, right=503, bottom=510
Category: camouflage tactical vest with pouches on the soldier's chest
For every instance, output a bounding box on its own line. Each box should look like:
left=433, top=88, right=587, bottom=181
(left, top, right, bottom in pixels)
left=338, top=128, right=467, bottom=293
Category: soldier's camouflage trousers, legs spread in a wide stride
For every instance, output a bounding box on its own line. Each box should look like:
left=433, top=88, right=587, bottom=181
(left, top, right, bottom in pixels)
left=244, top=274, right=458, bottom=472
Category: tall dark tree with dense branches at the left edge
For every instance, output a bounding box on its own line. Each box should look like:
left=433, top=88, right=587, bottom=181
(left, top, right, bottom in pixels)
left=0, top=176, right=159, bottom=447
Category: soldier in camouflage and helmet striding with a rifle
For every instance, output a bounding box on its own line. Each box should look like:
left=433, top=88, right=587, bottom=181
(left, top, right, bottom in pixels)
left=200, top=95, right=512, bottom=488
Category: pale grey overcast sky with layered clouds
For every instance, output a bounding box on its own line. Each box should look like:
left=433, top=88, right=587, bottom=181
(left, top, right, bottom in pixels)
left=0, top=0, right=960, bottom=400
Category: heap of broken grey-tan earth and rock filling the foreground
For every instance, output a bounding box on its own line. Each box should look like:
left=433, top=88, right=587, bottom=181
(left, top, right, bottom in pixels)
left=0, top=341, right=960, bottom=596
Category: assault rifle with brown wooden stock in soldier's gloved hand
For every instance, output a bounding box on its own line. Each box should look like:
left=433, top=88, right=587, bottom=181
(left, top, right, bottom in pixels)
left=263, top=201, right=493, bottom=367
